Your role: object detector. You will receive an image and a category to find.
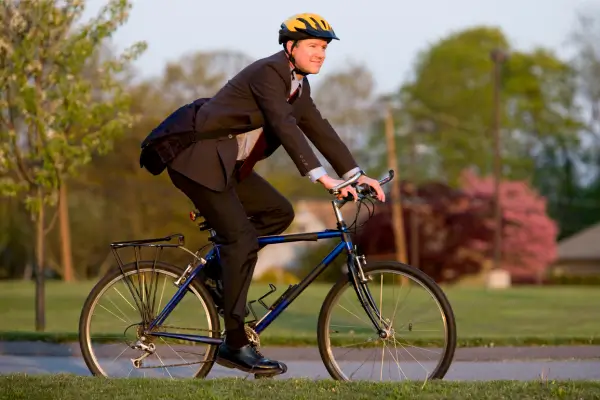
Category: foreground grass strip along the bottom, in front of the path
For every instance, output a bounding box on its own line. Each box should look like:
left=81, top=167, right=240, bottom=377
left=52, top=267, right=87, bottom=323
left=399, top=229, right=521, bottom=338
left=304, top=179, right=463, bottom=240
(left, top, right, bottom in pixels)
left=0, top=375, right=600, bottom=400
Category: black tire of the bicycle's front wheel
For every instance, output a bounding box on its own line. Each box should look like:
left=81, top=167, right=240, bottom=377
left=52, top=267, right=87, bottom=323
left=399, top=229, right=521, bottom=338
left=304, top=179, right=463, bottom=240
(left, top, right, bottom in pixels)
left=317, top=261, right=456, bottom=380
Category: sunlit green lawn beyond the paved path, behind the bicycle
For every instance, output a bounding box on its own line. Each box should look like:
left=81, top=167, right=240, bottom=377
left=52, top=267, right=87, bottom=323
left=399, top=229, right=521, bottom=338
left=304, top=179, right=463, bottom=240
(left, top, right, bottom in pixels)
left=0, top=281, right=600, bottom=346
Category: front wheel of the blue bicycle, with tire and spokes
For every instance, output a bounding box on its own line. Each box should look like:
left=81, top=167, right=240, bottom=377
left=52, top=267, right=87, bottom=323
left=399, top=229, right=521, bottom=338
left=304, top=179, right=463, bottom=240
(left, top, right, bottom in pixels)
left=317, top=262, right=456, bottom=381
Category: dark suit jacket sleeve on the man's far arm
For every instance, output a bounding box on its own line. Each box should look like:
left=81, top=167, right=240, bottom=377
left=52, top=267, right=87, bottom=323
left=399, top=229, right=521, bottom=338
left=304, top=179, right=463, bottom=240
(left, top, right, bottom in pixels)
left=298, top=80, right=358, bottom=176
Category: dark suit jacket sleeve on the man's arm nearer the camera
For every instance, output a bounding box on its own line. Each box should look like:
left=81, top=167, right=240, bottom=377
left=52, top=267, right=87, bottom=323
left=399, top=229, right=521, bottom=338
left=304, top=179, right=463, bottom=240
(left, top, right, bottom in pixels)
left=250, top=65, right=321, bottom=176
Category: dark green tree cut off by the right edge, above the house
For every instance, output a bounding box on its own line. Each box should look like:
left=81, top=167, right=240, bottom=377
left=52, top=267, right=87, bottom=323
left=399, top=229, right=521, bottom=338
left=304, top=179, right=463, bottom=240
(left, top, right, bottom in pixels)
left=538, top=4, right=600, bottom=238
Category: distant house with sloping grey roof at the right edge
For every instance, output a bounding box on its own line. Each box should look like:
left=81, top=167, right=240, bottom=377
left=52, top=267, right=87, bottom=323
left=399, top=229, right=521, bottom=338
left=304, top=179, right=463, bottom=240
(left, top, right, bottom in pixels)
left=548, top=223, right=600, bottom=275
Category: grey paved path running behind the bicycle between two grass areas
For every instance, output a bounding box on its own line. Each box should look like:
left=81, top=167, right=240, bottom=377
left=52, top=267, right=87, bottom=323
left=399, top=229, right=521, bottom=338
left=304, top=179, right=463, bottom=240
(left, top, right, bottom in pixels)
left=0, top=342, right=600, bottom=381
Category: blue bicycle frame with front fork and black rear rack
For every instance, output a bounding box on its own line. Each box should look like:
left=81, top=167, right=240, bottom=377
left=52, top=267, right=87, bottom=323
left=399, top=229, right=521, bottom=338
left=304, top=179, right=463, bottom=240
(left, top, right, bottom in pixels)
left=111, top=171, right=393, bottom=345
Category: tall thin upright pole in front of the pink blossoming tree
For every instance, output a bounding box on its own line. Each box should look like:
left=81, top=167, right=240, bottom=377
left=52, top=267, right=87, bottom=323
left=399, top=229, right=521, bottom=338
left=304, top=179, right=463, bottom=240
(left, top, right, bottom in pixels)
left=490, top=49, right=507, bottom=269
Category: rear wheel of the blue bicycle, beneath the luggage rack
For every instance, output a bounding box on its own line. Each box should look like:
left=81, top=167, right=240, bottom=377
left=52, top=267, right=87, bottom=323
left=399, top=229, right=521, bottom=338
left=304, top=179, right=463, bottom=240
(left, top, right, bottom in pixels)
left=79, top=261, right=220, bottom=378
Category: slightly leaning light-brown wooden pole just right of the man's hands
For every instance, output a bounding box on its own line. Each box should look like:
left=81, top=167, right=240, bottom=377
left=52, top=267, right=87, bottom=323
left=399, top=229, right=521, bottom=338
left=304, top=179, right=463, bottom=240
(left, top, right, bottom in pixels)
left=385, top=106, right=407, bottom=264
